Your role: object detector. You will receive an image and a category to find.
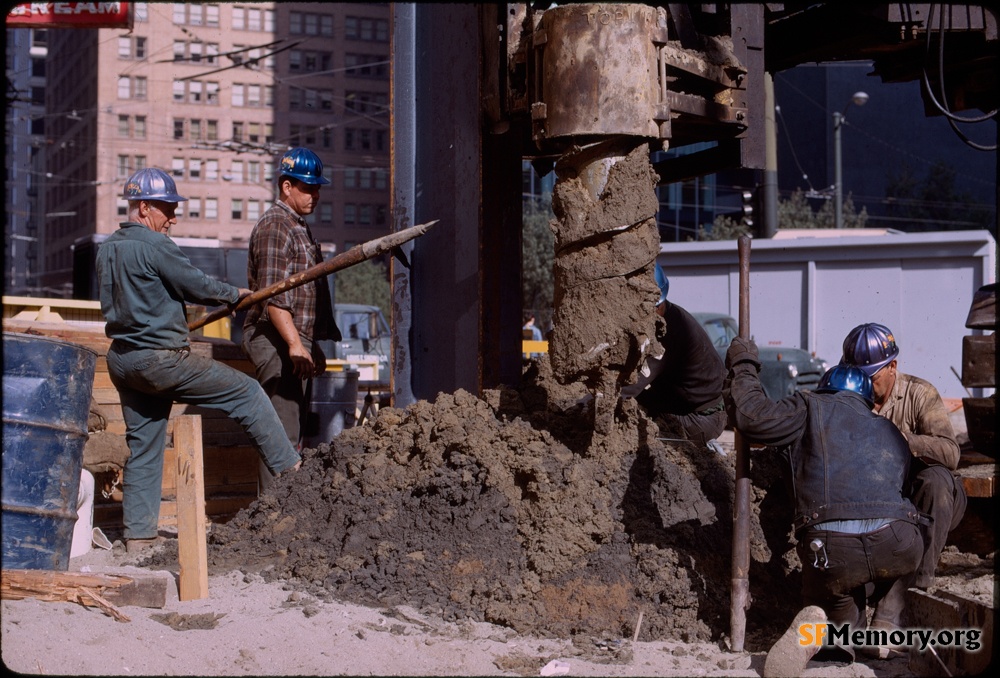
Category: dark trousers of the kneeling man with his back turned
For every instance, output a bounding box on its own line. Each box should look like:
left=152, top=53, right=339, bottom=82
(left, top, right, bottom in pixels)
left=796, top=520, right=924, bottom=629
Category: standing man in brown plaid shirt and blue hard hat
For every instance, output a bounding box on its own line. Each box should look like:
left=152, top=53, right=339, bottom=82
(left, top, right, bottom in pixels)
left=243, top=148, right=341, bottom=489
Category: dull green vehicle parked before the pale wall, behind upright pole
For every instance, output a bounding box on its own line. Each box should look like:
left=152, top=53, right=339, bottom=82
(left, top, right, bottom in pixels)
left=691, top=313, right=829, bottom=400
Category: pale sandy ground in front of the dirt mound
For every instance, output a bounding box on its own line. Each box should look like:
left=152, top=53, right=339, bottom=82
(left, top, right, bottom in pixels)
left=0, top=542, right=909, bottom=676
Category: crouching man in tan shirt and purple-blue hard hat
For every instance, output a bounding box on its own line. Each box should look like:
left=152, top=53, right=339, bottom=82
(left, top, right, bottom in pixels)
left=842, top=323, right=968, bottom=648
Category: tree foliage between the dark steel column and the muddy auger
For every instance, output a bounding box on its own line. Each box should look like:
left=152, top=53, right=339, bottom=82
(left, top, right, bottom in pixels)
left=521, top=197, right=555, bottom=328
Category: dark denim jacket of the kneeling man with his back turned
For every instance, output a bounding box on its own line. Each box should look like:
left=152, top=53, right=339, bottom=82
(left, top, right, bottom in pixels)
left=725, top=362, right=921, bottom=532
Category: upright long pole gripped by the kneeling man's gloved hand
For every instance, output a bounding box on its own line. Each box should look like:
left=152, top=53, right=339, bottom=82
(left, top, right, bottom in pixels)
left=729, top=235, right=750, bottom=652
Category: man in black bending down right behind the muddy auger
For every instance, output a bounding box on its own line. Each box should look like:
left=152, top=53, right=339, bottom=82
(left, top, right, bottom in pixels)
left=622, top=264, right=728, bottom=452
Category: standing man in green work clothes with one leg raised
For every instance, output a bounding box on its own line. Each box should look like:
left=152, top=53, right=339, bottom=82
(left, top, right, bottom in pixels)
left=97, top=168, right=301, bottom=552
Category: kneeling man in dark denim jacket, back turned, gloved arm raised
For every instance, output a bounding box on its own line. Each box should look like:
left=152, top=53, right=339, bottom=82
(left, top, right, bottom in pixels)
left=724, top=338, right=925, bottom=676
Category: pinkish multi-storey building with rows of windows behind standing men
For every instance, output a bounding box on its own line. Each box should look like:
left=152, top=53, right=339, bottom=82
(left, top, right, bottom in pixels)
left=32, top=3, right=391, bottom=288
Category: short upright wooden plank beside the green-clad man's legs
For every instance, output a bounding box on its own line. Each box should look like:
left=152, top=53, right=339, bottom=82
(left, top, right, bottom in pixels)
left=174, top=415, right=208, bottom=600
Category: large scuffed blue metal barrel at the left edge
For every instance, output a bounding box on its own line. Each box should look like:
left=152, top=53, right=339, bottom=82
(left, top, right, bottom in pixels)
left=2, top=332, right=97, bottom=570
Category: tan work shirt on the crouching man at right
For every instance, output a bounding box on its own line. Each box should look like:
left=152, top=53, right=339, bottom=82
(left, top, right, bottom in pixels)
left=878, top=372, right=960, bottom=471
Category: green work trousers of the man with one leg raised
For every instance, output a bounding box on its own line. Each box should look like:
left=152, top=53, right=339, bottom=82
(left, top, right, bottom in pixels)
left=107, top=342, right=300, bottom=539
